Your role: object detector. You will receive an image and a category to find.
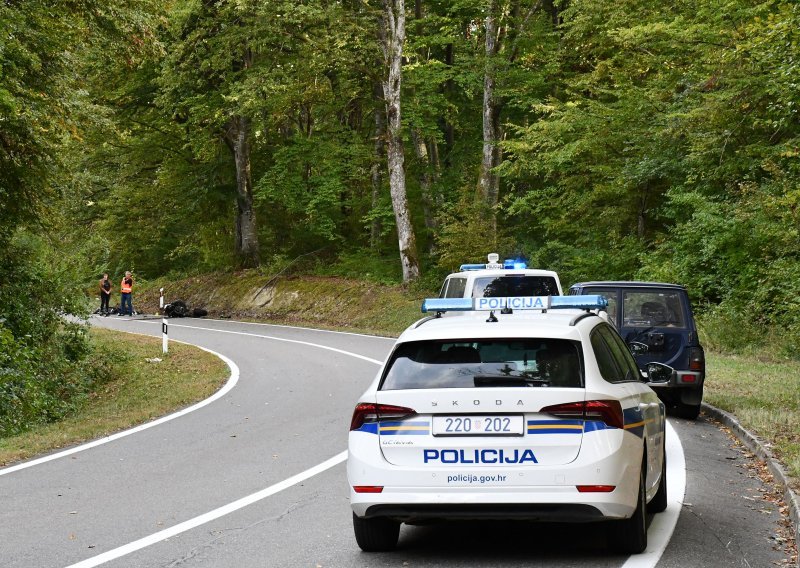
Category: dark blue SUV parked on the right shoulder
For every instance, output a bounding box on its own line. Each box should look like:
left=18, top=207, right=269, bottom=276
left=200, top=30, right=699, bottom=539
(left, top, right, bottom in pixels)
left=569, top=281, right=706, bottom=419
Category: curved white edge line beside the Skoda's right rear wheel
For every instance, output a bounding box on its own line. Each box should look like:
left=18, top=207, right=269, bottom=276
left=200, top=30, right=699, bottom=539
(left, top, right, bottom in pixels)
left=621, top=422, right=686, bottom=568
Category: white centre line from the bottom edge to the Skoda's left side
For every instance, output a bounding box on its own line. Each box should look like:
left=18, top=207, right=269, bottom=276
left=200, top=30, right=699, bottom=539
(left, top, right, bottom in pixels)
left=67, top=451, right=347, bottom=568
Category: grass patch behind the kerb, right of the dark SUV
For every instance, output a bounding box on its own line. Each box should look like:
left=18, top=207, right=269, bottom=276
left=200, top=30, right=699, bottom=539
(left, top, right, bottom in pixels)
left=704, top=353, right=800, bottom=491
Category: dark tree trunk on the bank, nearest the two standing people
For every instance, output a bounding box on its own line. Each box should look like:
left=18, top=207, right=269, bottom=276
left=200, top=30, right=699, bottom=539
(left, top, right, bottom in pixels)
left=224, top=116, right=260, bottom=268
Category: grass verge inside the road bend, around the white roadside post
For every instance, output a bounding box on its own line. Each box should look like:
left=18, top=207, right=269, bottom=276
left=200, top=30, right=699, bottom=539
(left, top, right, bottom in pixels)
left=0, top=328, right=230, bottom=465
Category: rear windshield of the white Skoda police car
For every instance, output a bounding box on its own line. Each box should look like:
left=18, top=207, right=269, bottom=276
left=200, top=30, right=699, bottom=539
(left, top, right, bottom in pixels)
left=380, top=339, right=583, bottom=390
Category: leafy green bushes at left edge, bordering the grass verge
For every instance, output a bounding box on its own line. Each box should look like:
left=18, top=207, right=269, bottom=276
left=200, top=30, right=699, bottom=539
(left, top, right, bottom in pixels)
left=0, top=232, right=120, bottom=437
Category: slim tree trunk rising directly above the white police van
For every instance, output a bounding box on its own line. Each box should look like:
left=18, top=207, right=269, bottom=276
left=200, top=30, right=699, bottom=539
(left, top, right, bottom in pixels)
left=478, top=0, right=500, bottom=234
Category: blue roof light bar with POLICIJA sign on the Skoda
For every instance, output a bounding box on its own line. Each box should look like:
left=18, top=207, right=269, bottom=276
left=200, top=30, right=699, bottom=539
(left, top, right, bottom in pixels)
left=422, top=295, right=608, bottom=314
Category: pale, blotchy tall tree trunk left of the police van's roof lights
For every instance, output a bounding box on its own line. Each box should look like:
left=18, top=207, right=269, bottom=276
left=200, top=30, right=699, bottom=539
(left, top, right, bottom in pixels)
left=380, top=0, right=419, bottom=283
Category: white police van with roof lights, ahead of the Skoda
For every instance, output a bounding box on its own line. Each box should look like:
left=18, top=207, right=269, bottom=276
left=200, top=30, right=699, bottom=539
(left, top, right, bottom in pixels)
left=439, top=253, right=564, bottom=298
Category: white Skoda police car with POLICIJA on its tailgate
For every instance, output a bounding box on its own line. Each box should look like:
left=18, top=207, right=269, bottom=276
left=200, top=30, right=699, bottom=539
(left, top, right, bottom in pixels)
left=347, top=296, right=671, bottom=553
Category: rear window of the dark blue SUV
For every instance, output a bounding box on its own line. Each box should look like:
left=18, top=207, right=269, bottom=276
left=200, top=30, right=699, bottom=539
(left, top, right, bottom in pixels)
left=622, top=290, right=686, bottom=328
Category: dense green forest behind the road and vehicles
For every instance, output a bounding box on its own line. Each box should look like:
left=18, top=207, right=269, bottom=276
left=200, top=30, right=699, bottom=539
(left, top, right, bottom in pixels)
left=0, top=0, right=800, bottom=430
